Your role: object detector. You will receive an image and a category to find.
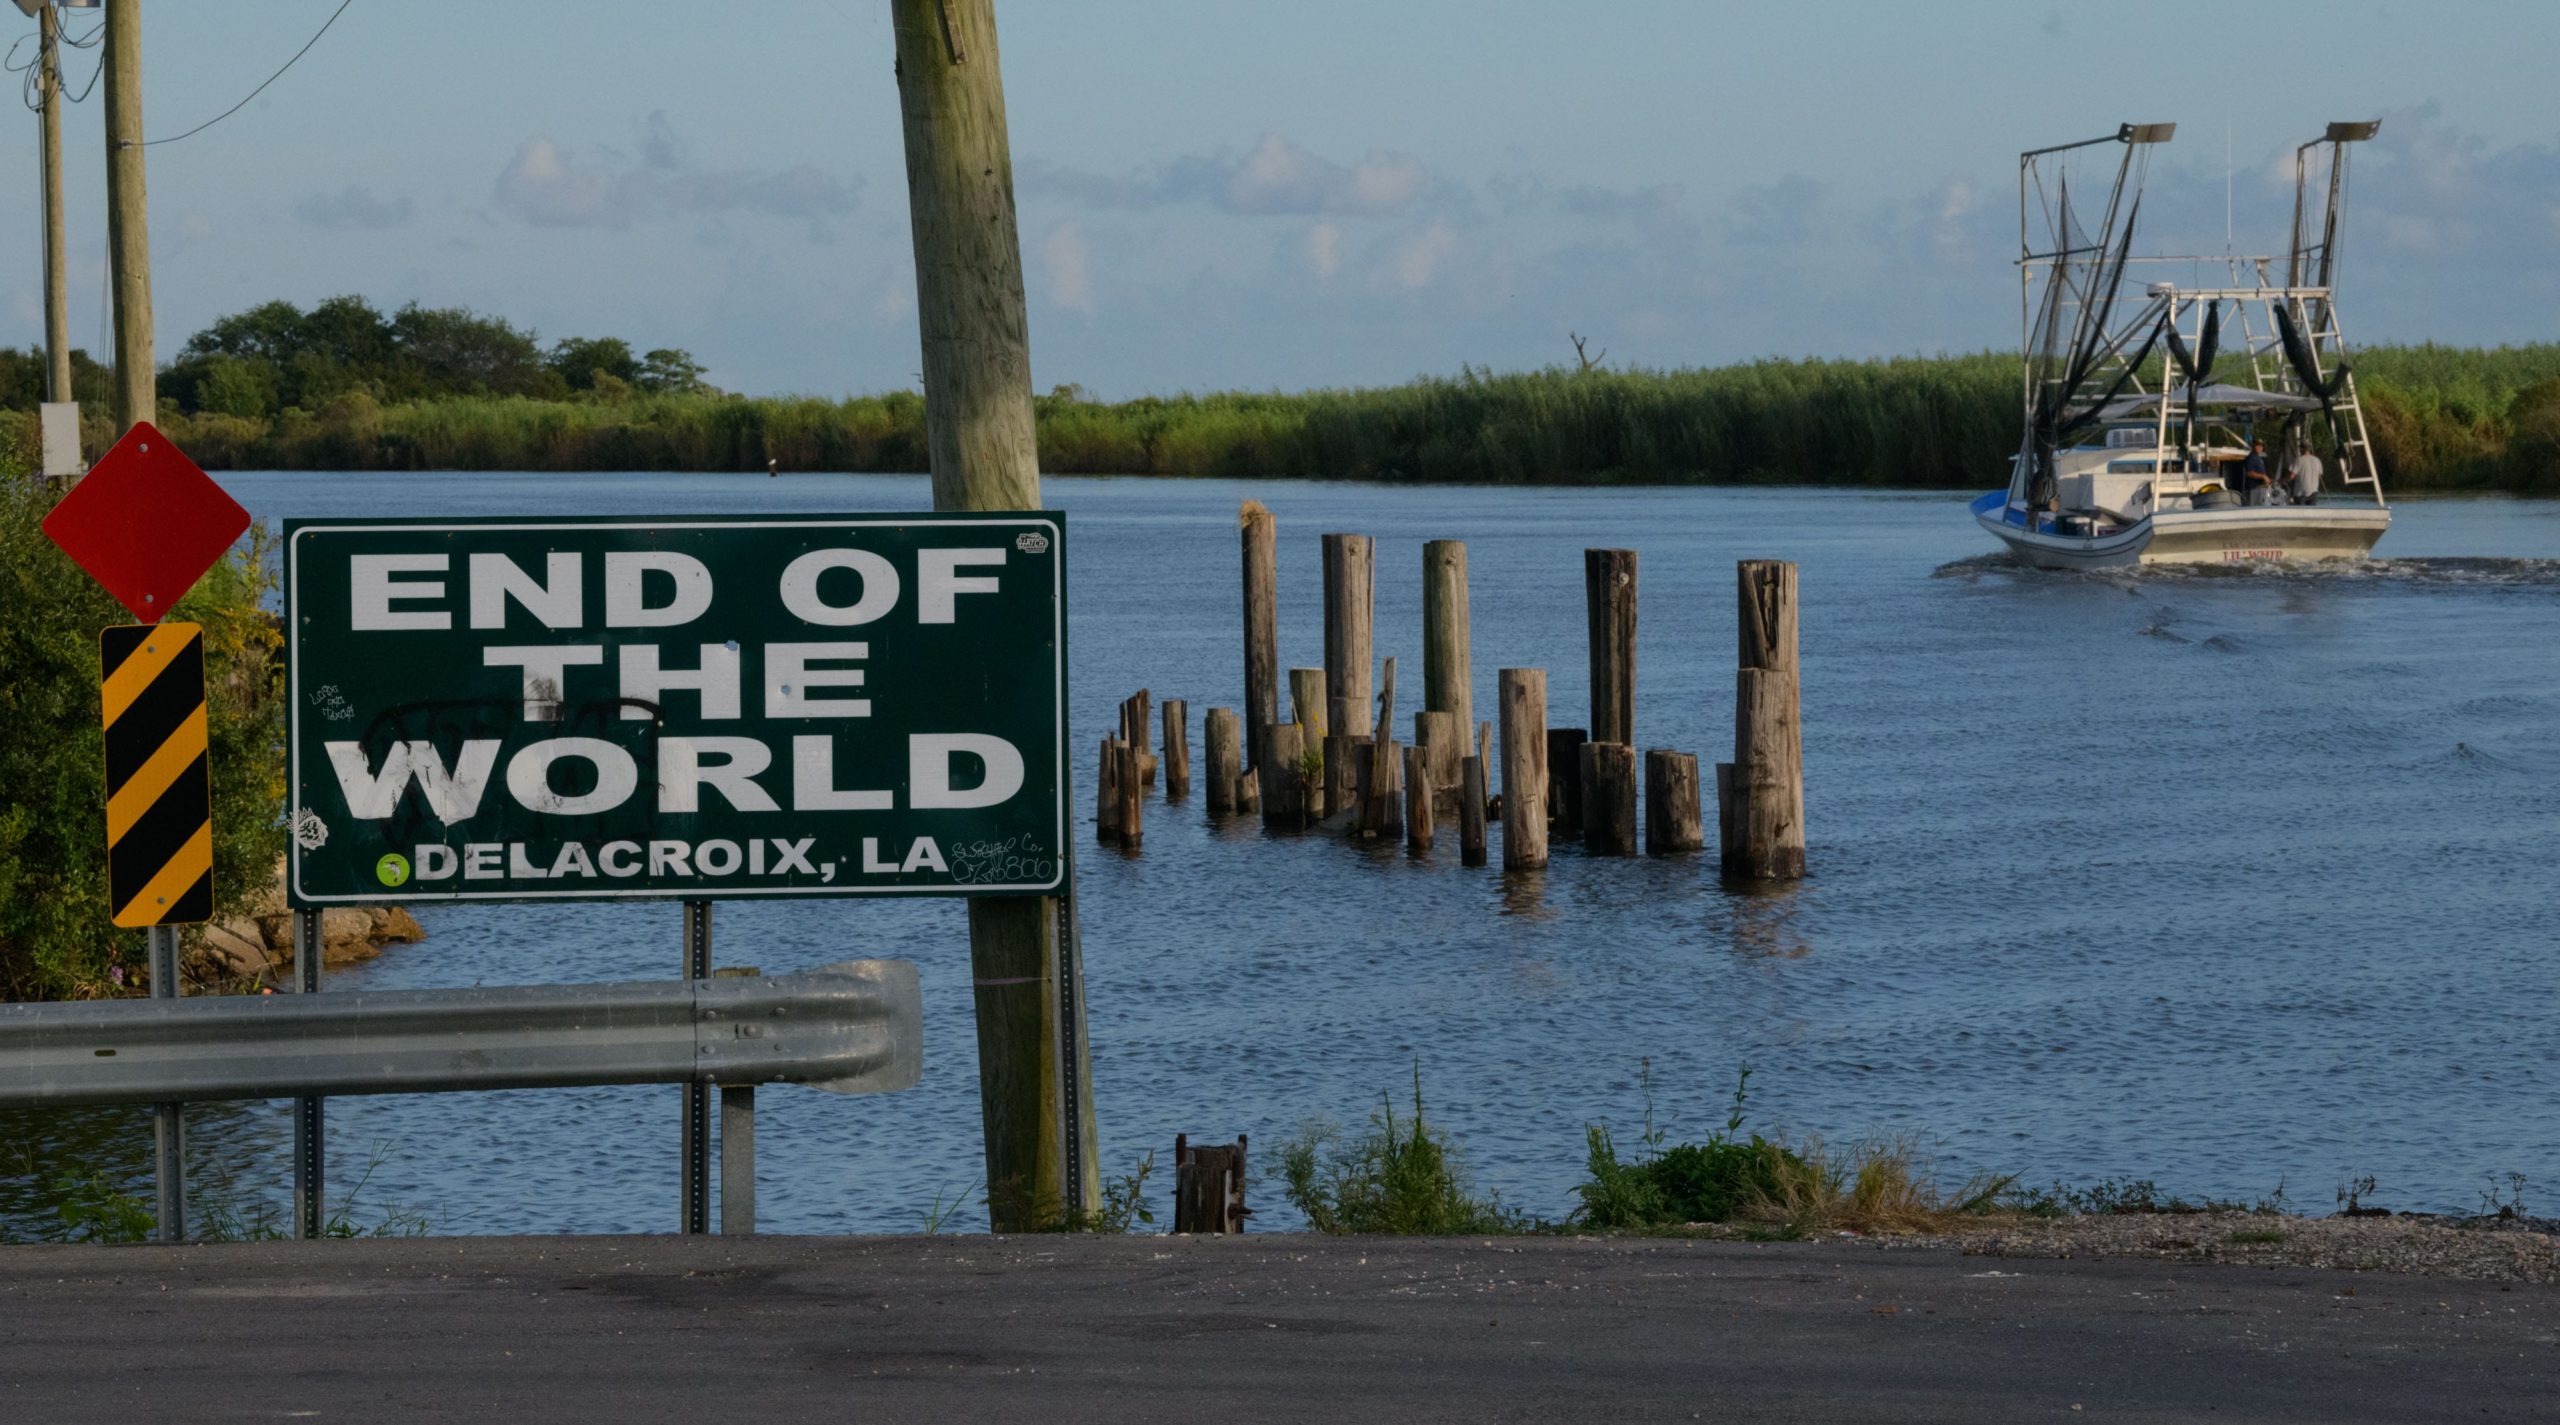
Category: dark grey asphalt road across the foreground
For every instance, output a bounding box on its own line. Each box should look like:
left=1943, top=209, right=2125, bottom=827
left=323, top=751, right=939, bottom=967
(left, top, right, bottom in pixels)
left=0, top=1236, right=2560, bottom=1425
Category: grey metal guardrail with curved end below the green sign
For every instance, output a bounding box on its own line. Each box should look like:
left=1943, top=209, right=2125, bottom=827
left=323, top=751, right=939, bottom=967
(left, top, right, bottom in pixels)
left=0, top=959, right=924, bottom=1108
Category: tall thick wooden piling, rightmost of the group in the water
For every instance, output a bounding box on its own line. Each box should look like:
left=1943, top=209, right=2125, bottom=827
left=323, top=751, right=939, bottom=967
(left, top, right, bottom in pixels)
left=1718, top=560, right=1805, bottom=880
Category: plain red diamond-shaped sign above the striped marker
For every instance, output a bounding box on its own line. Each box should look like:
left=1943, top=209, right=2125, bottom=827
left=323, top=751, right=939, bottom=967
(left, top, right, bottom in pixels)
left=44, top=420, right=248, bottom=624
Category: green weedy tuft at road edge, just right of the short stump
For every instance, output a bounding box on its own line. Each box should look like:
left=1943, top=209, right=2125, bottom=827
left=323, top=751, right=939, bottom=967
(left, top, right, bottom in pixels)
left=1280, top=1064, right=1539, bottom=1236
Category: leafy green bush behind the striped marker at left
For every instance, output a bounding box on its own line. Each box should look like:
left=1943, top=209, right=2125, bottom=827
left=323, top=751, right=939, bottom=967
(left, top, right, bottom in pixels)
left=0, top=448, right=284, bottom=1000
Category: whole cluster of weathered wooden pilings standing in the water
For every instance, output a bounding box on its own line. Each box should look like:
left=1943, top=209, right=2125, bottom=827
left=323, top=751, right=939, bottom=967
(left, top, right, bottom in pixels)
left=1096, top=501, right=1805, bottom=880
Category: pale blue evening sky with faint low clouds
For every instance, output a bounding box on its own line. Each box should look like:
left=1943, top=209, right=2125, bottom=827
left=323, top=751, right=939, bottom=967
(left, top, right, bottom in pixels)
left=0, top=0, right=2560, bottom=399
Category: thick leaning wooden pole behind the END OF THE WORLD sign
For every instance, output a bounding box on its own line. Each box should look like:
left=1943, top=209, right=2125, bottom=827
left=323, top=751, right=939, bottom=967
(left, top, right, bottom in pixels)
left=890, top=0, right=1101, bottom=1233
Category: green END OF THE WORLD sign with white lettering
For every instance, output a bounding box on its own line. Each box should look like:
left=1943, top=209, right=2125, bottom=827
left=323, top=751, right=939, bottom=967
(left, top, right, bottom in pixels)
left=284, top=512, right=1068, bottom=906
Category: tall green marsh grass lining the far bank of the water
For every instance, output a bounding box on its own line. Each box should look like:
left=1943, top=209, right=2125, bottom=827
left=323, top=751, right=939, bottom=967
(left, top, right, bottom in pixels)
left=15, top=343, right=2560, bottom=491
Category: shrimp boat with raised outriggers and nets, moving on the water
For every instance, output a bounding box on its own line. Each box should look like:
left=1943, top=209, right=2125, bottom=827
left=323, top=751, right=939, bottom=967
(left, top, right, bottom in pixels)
left=1971, top=123, right=2391, bottom=568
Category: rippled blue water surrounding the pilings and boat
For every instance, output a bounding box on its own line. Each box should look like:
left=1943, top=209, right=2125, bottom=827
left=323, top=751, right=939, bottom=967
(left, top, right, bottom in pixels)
left=0, top=473, right=2560, bottom=1233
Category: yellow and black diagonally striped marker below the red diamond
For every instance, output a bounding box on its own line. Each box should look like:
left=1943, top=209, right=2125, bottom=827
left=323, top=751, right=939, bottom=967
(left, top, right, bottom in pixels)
left=97, top=624, right=212, bottom=926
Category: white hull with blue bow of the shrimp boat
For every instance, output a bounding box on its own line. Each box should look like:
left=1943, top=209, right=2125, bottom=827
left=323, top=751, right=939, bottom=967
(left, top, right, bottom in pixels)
left=1974, top=501, right=2391, bottom=568
